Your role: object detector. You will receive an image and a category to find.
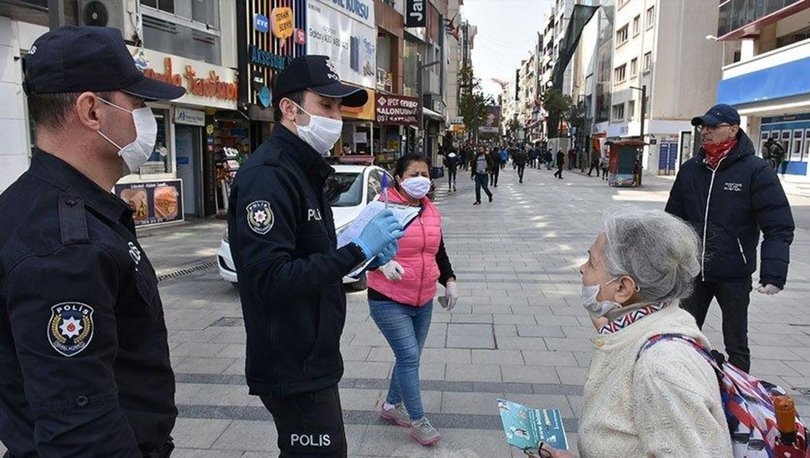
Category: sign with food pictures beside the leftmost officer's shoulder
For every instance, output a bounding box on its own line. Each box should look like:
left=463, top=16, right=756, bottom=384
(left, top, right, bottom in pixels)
left=115, top=180, right=183, bottom=226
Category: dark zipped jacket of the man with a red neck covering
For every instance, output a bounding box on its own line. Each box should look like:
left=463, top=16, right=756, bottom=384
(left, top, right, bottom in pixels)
left=666, top=131, right=794, bottom=288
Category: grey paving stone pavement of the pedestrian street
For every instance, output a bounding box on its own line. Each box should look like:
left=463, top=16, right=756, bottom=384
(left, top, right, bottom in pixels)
left=0, top=167, right=810, bottom=458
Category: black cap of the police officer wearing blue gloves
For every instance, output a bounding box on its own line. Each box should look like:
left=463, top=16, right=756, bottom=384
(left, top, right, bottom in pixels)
left=273, top=55, right=368, bottom=107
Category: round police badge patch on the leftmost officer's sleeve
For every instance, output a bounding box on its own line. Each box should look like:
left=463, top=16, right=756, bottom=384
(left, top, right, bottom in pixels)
left=48, top=302, right=93, bottom=357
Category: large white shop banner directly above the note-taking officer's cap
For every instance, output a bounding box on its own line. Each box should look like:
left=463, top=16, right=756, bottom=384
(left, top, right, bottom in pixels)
left=306, top=0, right=377, bottom=89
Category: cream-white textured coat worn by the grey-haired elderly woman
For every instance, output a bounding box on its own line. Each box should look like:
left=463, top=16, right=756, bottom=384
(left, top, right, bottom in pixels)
left=578, top=303, right=732, bottom=458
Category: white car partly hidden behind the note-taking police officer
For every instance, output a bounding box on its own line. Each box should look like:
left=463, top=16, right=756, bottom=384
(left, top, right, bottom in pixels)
left=217, top=165, right=394, bottom=291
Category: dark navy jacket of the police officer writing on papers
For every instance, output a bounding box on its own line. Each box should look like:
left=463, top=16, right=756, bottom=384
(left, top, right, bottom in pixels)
left=228, top=124, right=364, bottom=396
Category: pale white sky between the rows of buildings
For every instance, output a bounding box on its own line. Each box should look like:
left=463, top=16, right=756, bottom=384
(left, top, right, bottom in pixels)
left=461, top=0, right=554, bottom=99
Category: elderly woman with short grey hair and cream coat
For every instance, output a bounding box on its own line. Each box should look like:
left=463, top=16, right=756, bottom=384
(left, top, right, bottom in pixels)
left=540, top=207, right=732, bottom=458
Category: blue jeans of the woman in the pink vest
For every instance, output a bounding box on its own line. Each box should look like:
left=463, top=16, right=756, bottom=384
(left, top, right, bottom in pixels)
left=368, top=300, right=433, bottom=421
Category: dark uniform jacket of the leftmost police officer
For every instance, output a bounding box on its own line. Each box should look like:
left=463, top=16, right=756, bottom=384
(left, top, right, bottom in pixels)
left=0, top=149, right=177, bottom=457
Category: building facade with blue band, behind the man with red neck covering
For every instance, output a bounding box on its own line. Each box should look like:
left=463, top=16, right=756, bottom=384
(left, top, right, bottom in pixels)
left=712, top=0, right=810, bottom=185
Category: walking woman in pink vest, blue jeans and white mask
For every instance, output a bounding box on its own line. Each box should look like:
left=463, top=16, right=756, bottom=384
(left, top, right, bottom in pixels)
left=368, top=154, right=458, bottom=445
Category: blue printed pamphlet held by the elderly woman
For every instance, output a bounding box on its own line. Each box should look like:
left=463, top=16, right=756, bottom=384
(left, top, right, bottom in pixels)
left=498, top=399, right=568, bottom=451
